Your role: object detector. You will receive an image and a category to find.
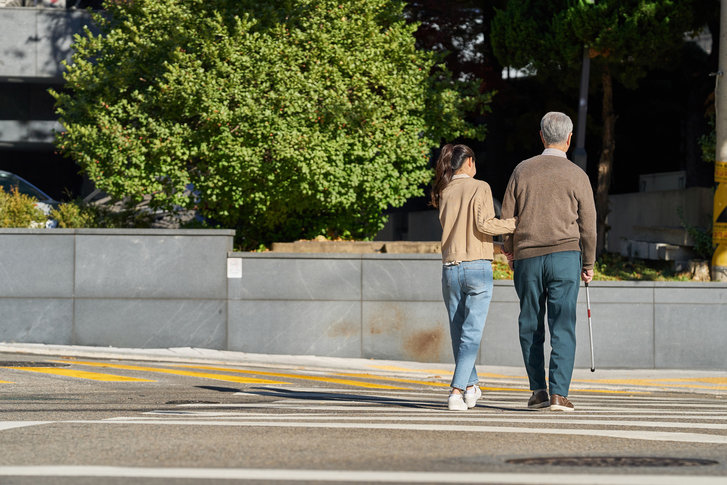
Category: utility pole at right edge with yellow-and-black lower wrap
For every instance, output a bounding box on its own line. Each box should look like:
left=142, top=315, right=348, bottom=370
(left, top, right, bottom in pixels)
left=712, top=0, right=727, bottom=281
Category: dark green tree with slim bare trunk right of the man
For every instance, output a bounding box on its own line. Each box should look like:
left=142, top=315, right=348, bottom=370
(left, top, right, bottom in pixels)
left=491, top=0, right=704, bottom=253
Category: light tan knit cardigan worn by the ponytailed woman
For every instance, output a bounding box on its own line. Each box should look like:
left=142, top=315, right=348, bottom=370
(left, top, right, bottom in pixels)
left=439, top=177, right=516, bottom=263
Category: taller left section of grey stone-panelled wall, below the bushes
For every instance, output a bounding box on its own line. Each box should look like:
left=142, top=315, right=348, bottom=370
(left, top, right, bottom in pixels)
left=0, top=229, right=234, bottom=349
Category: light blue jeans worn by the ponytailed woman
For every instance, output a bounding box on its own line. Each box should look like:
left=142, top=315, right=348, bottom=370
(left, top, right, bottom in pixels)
left=442, top=259, right=492, bottom=390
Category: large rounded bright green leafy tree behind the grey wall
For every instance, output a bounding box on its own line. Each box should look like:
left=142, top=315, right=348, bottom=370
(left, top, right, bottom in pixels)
left=53, top=0, right=489, bottom=248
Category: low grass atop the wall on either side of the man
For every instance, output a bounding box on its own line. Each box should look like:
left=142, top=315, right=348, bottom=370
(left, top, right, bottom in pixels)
left=492, top=253, right=691, bottom=281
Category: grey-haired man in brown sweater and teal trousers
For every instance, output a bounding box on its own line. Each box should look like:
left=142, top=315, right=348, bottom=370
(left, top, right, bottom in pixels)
left=502, top=112, right=596, bottom=411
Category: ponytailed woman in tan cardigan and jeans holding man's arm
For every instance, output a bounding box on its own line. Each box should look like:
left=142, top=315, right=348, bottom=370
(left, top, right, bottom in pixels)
left=431, top=144, right=517, bottom=411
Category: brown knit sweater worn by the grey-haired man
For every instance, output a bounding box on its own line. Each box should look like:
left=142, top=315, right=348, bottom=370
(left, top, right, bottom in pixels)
left=502, top=155, right=596, bottom=269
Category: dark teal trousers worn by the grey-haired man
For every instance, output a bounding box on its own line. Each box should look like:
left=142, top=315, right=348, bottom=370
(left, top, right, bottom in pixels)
left=514, top=251, right=581, bottom=396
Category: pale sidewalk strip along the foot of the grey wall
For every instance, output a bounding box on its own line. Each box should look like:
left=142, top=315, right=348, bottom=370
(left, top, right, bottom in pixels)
left=0, top=343, right=727, bottom=398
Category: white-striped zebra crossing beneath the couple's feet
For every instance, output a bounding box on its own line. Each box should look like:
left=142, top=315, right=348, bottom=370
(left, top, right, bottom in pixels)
left=75, top=388, right=727, bottom=445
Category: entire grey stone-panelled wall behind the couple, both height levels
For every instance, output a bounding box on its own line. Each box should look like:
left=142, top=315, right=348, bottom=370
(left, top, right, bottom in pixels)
left=0, top=229, right=727, bottom=369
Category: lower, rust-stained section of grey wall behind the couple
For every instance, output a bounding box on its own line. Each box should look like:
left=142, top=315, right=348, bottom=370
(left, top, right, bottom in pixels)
left=228, top=253, right=727, bottom=369
